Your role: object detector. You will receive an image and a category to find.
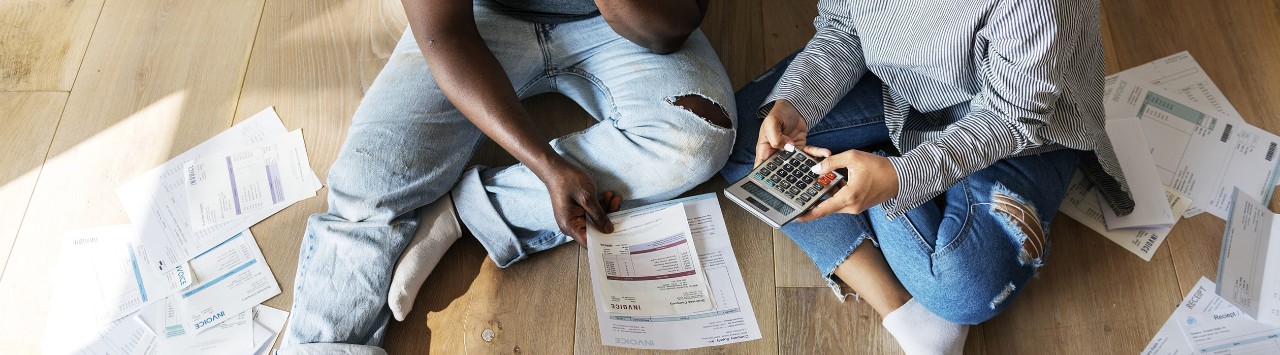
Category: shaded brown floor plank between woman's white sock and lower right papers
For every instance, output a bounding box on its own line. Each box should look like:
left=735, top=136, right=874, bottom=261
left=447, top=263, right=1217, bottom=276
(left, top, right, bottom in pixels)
left=983, top=214, right=1181, bottom=354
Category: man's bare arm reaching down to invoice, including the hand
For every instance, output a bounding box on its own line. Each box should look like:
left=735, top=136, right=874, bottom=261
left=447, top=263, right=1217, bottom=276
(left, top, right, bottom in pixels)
left=402, top=0, right=613, bottom=242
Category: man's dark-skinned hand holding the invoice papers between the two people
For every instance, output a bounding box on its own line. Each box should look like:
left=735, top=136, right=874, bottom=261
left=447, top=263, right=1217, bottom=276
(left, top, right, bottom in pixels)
left=543, top=160, right=621, bottom=247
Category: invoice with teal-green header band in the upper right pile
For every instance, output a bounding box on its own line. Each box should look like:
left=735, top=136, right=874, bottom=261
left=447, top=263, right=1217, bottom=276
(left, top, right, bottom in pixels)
left=1105, top=77, right=1280, bottom=219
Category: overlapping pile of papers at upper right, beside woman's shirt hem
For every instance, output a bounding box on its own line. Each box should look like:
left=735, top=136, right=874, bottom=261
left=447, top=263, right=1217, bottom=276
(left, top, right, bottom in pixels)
left=1060, top=51, right=1280, bottom=260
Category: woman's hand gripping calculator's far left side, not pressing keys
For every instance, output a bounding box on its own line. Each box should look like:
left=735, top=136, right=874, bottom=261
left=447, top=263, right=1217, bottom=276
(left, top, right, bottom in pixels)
left=753, top=100, right=831, bottom=168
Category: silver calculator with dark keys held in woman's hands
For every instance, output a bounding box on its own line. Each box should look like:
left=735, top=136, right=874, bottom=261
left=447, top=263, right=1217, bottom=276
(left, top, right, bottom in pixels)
left=724, top=150, right=845, bottom=228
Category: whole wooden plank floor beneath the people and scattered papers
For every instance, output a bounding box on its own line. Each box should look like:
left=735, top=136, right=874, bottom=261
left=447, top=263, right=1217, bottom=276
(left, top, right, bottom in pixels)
left=0, top=0, right=1280, bottom=354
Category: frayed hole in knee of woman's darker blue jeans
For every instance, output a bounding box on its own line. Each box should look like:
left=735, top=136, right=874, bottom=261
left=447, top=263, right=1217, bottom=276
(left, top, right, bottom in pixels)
left=991, top=188, right=1046, bottom=268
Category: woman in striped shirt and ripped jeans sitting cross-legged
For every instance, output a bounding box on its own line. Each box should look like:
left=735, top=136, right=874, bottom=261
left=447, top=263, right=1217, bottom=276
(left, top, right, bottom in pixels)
left=721, top=0, right=1133, bottom=354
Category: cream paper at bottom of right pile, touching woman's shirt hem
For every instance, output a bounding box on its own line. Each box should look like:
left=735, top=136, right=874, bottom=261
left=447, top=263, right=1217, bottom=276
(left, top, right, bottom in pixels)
left=1059, top=170, right=1192, bottom=261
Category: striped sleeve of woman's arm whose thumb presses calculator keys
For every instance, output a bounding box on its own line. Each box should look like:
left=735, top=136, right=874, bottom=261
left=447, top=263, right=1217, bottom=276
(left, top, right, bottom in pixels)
left=882, top=0, right=1087, bottom=215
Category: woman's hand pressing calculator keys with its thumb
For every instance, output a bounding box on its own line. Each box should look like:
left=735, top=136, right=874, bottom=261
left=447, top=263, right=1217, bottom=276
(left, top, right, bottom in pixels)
left=796, top=150, right=897, bottom=222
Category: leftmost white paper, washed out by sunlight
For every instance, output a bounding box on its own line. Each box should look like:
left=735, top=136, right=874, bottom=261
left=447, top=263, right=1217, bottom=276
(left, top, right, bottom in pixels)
left=51, top=224, right=192, bottom=326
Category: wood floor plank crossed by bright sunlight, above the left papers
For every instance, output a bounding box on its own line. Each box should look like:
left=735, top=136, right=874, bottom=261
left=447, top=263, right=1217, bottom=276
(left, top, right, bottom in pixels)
left=0, top=0, right=262, bottom=354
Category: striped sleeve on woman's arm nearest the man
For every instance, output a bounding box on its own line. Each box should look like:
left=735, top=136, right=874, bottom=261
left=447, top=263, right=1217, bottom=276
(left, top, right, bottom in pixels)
left=758, top=0, right=867, bottom=127
